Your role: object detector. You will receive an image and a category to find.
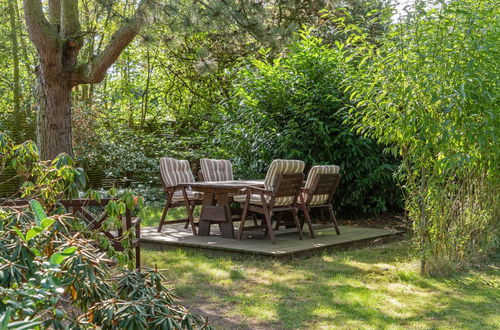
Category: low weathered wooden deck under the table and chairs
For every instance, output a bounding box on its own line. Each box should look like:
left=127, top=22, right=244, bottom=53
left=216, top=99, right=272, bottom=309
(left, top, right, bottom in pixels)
left=141, top=224, right=402, bottom=257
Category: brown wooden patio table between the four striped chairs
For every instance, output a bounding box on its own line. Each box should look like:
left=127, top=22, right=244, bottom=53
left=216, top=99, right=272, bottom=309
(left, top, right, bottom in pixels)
left=179, top=180, right=264, bottom=238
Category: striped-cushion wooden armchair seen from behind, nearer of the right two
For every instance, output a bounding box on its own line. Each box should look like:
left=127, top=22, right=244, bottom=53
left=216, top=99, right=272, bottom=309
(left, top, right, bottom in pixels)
left=234, top=159, right=314, bottom=243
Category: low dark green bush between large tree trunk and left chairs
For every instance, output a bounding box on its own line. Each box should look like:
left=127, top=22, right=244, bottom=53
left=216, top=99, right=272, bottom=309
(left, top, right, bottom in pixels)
left=75, top=123, right=229, bottom=189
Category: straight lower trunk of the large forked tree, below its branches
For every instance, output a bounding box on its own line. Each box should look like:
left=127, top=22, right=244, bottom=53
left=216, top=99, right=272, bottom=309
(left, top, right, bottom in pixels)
left=37, top=77, right=73, bottom=159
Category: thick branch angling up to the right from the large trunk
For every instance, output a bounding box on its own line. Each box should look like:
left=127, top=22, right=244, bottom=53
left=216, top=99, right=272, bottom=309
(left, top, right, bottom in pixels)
left=71, top=0, right=148, bottom=86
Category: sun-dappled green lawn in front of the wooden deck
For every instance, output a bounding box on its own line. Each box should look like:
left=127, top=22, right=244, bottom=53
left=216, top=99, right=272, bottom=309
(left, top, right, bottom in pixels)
left=143, top=241, right=500, bottom=329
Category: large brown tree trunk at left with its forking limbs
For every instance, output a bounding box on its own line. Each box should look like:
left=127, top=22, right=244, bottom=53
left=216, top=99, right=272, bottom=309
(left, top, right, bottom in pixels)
left=23, top=0, right=147, bottom=159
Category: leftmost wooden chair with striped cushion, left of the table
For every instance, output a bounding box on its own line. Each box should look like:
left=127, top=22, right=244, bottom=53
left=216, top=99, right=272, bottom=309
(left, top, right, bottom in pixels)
left=158, top=157, right=203, bottom=235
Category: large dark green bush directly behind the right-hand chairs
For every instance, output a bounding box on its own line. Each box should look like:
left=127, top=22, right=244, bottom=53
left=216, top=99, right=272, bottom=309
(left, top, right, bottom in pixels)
left=222, top=30, right=401, bottom=216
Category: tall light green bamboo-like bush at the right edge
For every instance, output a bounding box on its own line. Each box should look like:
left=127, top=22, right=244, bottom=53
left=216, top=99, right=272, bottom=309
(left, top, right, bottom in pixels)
left=340, top=0, right=500, bottom=274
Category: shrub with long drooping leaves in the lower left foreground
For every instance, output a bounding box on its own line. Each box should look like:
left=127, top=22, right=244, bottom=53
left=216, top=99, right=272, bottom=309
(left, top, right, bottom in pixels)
left=0, top=134, right=208, bottom=329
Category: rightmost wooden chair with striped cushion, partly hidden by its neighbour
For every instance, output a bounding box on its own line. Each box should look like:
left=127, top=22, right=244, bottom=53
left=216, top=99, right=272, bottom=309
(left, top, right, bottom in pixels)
left=299, top=165, right=340, bottom=235
